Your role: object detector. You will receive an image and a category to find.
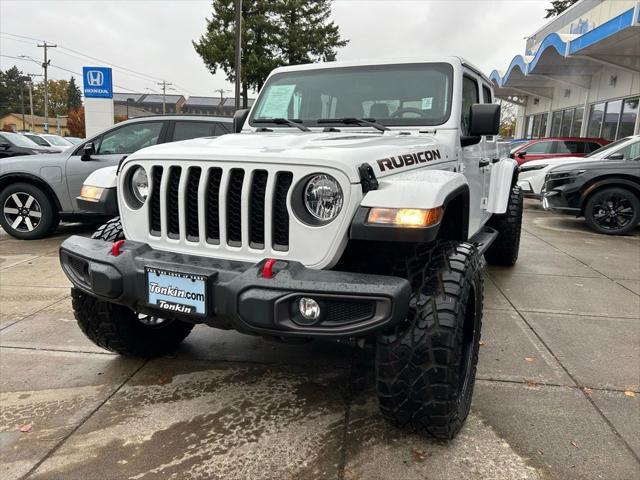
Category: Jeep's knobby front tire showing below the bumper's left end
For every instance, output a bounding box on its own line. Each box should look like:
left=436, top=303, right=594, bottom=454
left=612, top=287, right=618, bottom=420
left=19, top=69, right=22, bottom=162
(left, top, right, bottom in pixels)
left=71, top=288, right=193, bottom=358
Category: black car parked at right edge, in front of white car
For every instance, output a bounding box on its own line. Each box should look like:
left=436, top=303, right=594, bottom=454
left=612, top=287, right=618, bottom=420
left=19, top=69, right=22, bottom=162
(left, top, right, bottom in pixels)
left=542, top=152, right=640, bottom=235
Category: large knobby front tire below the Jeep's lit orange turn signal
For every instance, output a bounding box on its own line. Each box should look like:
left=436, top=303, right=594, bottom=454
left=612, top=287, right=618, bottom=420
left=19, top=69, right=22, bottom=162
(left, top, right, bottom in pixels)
left=376, top=242, right=483, bottom=439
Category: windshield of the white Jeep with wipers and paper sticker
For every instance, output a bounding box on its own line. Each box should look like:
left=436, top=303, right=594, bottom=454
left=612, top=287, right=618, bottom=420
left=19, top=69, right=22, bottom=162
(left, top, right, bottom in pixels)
left=249, top=63, right=453, bottom=127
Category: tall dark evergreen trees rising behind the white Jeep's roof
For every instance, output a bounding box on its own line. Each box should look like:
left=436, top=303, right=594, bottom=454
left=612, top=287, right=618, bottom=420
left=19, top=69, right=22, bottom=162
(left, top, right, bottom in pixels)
left=193, top=0, right=347, bottom=108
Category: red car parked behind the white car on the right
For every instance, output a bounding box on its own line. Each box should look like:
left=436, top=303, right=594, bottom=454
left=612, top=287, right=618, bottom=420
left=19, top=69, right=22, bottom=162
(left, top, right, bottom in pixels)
left=511, top=137, right=610, bottom=165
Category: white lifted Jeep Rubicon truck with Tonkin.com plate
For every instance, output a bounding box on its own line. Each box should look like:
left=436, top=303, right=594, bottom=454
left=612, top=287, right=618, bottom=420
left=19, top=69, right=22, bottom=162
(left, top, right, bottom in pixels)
left=60, top=57, right=522, bottom=438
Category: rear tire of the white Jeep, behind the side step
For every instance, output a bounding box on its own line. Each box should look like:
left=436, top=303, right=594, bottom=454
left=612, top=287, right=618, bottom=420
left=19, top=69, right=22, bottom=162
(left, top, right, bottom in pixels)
left=484, top=185, right=523, bottom=267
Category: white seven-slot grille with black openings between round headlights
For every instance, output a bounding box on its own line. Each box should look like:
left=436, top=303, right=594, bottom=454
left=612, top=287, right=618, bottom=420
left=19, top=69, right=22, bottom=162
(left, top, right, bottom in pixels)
left=148, top=166, right=293, bottom=251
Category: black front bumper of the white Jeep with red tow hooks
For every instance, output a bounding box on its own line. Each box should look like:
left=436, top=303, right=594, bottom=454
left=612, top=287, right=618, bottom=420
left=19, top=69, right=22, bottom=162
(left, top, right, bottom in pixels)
left=60, top=236, right=411, bottom=338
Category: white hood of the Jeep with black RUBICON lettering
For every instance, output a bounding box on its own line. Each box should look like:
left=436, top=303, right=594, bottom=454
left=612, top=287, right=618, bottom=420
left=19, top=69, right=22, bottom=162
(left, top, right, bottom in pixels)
left=126, top=130, right=453, bottom=183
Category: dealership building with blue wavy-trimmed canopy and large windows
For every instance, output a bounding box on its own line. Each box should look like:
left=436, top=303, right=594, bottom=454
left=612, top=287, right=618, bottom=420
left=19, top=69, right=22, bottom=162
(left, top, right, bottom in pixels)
left=490, top=0, right=640, bottom=141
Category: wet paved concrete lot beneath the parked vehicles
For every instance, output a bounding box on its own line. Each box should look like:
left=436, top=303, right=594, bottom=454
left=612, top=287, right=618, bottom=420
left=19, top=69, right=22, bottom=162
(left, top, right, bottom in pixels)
left=0, top=202, right=640, bottom=480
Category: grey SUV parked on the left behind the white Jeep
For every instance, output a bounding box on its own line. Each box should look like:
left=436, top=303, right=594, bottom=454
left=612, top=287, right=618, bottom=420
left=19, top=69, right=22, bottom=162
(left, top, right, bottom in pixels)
left=0, top=115, right=232, bottom=240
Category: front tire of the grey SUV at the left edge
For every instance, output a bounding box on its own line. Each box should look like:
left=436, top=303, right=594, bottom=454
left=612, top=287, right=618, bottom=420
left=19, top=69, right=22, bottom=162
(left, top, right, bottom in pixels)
left=0, top=183, right=60, bottom=240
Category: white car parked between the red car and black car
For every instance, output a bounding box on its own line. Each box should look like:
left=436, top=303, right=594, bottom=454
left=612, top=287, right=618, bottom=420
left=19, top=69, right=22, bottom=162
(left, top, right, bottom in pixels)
left=518, top=135, right=640, bottom=199
